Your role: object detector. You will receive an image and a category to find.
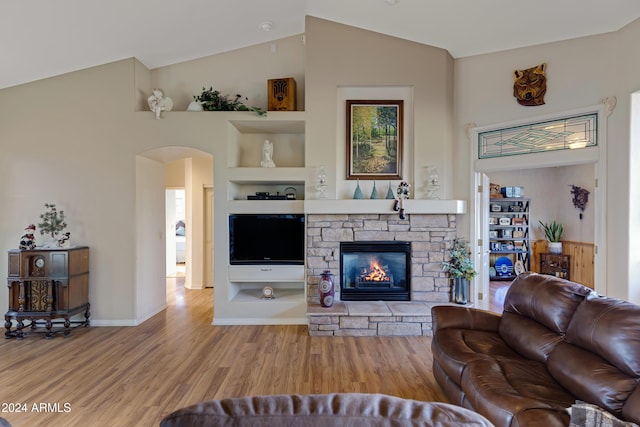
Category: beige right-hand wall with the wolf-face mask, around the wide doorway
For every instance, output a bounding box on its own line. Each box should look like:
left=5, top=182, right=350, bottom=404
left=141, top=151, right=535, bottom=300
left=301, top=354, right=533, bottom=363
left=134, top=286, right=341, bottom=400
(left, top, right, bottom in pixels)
left=454, top=21, right=640, bottom=302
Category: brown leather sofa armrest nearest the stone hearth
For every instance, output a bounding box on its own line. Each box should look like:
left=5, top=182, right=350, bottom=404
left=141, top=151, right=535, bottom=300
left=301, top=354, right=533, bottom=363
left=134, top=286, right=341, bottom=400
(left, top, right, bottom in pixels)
left=431, top=305, right=502, bottom=334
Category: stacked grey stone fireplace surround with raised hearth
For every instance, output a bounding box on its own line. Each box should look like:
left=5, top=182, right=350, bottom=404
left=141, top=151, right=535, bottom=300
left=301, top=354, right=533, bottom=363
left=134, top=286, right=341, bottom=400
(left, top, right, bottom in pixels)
left=306, top=214, right=456, bottom=336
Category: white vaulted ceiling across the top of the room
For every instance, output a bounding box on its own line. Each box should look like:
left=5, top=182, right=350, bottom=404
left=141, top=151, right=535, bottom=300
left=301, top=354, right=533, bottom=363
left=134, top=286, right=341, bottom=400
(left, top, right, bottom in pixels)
left=0, top=0, right=640, bottom=88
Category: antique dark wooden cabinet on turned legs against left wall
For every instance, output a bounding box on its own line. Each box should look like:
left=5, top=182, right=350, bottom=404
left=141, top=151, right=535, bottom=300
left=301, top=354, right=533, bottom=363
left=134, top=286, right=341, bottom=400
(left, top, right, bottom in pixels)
left=4, top=246, right=90, bottom=338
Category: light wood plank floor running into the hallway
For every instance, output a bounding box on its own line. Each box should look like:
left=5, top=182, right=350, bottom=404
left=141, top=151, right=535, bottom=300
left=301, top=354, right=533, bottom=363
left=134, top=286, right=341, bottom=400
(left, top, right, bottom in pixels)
left=0, top=279, right=447, bottom=427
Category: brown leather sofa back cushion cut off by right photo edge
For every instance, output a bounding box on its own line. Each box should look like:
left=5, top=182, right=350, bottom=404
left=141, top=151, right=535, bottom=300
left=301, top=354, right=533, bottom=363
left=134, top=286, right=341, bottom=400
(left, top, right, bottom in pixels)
left=547, top=293, right=640, bottom=423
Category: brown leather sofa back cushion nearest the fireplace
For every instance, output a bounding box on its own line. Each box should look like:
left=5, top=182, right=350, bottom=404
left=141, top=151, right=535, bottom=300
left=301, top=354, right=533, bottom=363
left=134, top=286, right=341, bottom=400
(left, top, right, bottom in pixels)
left=498, top=273, right=591, bottom=362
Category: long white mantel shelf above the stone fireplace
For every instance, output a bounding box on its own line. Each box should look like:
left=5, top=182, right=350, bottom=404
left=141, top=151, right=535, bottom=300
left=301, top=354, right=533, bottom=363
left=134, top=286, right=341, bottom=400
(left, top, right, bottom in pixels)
left=304, top=199, right=467, bottom=214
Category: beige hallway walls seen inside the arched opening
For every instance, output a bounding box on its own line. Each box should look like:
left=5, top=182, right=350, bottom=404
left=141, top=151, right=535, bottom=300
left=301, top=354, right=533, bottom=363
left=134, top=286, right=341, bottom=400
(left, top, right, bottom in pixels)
left=135, top=146, right=213, bottom=322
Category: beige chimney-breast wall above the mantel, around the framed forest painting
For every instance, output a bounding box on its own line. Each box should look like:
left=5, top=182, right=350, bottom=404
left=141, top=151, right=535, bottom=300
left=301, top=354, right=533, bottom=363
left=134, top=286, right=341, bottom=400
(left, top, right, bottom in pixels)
left=305, top=16, right=456, bottom=199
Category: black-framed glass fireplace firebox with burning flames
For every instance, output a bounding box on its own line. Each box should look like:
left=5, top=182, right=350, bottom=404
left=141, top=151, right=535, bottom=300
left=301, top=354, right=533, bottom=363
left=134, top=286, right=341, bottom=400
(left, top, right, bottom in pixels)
left=340, top=241, right=411, bottom=301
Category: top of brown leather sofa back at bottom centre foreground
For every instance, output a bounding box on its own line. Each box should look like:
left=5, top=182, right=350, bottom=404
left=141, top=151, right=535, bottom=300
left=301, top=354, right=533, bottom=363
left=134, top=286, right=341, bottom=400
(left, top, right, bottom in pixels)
left=160, top=393, right=492, bottom=427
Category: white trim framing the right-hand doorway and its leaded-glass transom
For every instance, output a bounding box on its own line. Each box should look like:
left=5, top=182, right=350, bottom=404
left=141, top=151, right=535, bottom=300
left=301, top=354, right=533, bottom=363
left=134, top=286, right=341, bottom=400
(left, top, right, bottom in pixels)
left=468, top=103, right=612, bottom=309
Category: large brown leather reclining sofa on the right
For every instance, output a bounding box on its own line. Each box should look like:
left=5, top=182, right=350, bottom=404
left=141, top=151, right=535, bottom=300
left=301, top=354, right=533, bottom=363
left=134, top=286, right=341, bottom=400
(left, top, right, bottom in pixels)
left=432, top=273, right=640, bottom=427
